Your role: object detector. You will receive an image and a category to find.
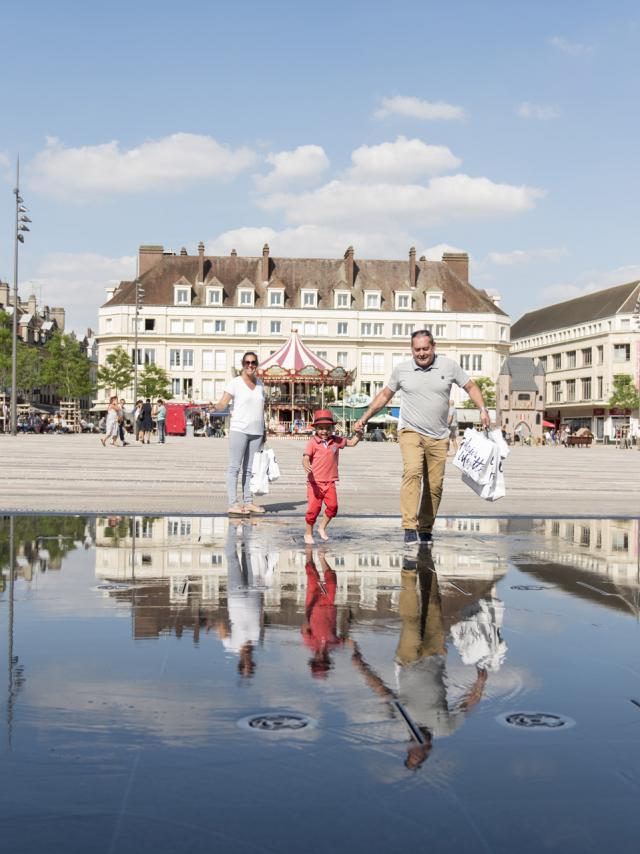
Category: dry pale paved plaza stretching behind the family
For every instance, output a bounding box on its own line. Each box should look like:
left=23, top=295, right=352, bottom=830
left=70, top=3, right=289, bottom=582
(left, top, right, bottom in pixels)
left=0, top=435, right=640, bottom=517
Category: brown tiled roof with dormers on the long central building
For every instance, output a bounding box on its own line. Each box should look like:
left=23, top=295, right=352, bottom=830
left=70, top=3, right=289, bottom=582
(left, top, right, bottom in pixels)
left=105, top=255, right=506, bottom=317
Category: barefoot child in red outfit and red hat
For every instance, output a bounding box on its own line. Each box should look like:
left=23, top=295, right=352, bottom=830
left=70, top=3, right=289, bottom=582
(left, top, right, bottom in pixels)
left=302, top=409, right=362, bottom=545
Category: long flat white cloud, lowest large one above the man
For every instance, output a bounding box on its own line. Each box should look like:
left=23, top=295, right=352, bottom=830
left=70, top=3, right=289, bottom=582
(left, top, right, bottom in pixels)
left=260, top=174, right=545, bottom=227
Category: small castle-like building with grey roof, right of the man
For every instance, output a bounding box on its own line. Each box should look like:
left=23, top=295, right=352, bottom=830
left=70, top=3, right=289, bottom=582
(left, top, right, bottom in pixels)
left=496, top=356, right=544, bottom=441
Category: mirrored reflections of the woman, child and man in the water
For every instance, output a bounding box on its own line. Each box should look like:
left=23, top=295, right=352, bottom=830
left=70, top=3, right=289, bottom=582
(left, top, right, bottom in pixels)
left=212, top=524, right=506, bottom=769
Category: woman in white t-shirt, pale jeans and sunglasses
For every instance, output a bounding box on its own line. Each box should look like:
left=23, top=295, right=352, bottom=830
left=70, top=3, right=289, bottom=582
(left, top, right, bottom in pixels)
left=214, top=352, right=264, bottom=516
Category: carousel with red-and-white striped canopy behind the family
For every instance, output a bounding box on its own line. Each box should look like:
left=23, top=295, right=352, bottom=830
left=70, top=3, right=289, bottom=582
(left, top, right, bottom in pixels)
left=258, top=331, right=354, bottom=433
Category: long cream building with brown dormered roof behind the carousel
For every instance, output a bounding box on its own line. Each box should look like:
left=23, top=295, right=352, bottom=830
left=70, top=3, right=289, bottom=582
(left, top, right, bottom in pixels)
left=98, top=243, right=510, bottom=412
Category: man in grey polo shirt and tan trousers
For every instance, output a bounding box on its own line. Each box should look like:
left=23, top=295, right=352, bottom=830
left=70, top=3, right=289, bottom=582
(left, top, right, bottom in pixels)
left=355, top=329, right=490, bottom=543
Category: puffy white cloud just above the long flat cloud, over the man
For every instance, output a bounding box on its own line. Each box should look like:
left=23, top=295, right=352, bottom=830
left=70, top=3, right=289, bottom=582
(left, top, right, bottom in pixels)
left=349, top=136, right=462, bottom=181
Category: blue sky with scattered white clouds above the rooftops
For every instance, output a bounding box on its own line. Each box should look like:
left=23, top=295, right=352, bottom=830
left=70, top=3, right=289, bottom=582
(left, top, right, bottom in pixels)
left=0, top=0, right=640, bottom=330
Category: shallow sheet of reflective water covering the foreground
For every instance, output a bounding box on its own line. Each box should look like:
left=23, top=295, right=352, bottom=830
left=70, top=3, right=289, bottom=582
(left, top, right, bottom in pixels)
left=0, top=516, right=640, bottom=854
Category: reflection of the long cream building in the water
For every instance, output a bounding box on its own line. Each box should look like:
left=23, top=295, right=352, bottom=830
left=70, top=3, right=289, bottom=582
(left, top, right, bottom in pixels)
left=96, top=516, right=506, bottom=637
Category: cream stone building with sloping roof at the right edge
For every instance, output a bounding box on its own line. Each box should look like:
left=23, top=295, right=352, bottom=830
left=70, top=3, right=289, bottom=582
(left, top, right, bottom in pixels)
left=511, top=281, right=640, bottom=441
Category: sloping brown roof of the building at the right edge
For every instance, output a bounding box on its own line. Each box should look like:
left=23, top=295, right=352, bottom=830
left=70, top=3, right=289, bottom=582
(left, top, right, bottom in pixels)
left=511, top=281, right=640, bottom=341
